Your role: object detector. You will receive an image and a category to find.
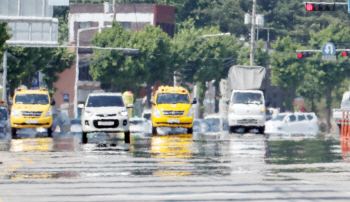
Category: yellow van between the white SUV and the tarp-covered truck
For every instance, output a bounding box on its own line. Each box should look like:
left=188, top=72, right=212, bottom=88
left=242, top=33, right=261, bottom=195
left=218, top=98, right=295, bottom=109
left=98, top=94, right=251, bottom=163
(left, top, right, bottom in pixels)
left=151, top=86, right=197, bottom=134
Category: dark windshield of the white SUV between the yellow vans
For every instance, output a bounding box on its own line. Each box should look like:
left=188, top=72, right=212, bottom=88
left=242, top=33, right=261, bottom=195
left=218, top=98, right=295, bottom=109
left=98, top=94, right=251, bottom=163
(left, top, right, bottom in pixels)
left=86, top=95, right=124, bottom=107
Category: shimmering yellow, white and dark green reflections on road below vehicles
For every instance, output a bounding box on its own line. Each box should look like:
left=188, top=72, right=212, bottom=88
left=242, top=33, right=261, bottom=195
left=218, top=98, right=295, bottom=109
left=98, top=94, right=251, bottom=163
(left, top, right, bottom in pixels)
left=0, top=129, right=344, bottom=178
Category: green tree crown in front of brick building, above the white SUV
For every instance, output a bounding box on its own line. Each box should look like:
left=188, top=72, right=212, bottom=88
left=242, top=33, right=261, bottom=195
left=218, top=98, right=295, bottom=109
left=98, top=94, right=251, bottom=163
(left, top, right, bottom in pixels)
left=90, top=22, right=174, bottom=105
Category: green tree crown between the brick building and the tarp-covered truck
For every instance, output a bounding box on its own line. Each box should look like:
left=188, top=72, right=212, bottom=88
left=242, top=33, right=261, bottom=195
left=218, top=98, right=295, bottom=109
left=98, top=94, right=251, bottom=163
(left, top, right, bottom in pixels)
left=173, top=19, right=240, bottom=86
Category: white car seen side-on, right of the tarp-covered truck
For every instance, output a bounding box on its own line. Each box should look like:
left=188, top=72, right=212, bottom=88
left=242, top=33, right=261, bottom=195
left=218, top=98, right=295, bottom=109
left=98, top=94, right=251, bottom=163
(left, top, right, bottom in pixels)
left=265, top=112, right=318, bottom=135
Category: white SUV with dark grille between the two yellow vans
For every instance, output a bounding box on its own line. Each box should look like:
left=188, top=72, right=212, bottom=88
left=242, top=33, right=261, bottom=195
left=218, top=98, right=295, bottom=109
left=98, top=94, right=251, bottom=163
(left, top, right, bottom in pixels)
left=78, top=93, right=133, bottom=144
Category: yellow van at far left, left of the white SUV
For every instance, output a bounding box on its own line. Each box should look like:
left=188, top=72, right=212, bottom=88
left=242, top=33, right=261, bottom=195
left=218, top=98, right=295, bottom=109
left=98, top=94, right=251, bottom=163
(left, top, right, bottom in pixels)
left=11, top=88, right=55, bottom=139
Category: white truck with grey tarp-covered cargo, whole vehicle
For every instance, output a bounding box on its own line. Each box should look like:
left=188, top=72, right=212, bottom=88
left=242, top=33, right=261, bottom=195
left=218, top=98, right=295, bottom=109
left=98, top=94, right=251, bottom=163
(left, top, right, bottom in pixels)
left=226, top=65, right=267, bottom=134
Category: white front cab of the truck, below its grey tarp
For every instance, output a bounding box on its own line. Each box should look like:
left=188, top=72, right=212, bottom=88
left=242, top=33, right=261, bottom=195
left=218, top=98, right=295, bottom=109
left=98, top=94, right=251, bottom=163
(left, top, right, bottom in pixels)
left=228, top=90, right=266, bottom=134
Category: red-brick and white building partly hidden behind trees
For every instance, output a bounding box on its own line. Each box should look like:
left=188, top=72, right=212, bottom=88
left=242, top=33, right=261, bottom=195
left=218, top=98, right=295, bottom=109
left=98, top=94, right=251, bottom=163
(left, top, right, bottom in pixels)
left=53, top=2, right=175, bottom=117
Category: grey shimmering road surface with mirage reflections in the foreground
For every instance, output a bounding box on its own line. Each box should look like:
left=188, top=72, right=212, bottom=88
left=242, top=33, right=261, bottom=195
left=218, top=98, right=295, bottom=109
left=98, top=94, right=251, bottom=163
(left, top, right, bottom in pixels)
left=0, top=130, right=350, bottom=202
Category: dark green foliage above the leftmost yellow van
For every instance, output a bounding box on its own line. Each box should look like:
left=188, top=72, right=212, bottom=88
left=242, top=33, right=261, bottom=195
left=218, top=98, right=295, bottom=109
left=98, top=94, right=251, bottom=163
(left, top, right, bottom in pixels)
left=7, top=47, right=75, bottom=92
